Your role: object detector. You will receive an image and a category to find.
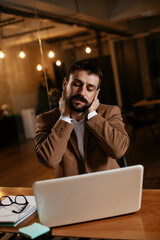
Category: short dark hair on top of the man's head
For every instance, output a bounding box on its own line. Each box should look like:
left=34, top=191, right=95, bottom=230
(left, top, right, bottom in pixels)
left=67, top=60, right=103, bottom=89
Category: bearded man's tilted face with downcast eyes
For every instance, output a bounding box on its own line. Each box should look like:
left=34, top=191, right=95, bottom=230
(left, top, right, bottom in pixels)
left=63, top=70, right=99, bottom=112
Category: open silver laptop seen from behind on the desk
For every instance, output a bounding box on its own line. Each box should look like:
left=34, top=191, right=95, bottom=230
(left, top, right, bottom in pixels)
left=33, top=165, right=143, bottom=227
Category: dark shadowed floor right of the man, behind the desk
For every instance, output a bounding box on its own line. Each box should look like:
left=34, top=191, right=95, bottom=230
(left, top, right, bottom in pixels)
left=126, top=121, right=160, bottom=189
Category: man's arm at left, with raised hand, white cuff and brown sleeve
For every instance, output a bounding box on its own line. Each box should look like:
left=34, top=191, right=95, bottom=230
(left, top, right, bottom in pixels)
left=35, top=89, right=73, bottom=168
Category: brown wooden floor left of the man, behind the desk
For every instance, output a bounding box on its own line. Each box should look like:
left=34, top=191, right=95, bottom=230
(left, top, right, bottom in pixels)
left=0, top=140, right=53, bottom=187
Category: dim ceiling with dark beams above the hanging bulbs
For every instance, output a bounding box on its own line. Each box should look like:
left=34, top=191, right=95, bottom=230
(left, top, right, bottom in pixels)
left=0, top=0, right=160, bottom=46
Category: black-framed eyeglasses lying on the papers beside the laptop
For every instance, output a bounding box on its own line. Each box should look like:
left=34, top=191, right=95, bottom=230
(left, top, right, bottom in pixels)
left=0, top=195, right=29, bottom=213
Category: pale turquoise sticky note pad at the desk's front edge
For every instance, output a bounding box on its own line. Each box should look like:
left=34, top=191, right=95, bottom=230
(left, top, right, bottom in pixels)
left=18, top=223, right=50, bottom=239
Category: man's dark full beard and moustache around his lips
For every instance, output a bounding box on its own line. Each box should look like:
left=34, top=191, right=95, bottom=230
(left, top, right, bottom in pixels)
left=66, top=94, right=93, bottom=113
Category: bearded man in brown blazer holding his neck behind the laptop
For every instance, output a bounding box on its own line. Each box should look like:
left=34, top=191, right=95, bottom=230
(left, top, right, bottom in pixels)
left=35, top=60, right=129, bottom=177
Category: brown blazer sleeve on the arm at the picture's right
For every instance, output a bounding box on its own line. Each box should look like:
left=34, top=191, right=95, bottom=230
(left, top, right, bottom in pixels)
left=86, top=106, right=129, bottom=159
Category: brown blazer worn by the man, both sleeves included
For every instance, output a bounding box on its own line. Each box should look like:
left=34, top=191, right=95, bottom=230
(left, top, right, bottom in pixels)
left=35, top=104, right=129, bottom=177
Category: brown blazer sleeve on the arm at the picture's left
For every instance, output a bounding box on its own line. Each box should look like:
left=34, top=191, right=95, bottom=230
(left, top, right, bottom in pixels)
left=35, top=115, right=73, bottom=168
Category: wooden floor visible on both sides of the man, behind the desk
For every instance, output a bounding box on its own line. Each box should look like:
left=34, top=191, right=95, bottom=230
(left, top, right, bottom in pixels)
left=0, top=121, right=160, bottom=188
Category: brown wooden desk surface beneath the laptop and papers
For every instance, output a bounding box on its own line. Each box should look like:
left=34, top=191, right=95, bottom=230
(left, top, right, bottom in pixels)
left=0, top=188, right=160, bottom=240
